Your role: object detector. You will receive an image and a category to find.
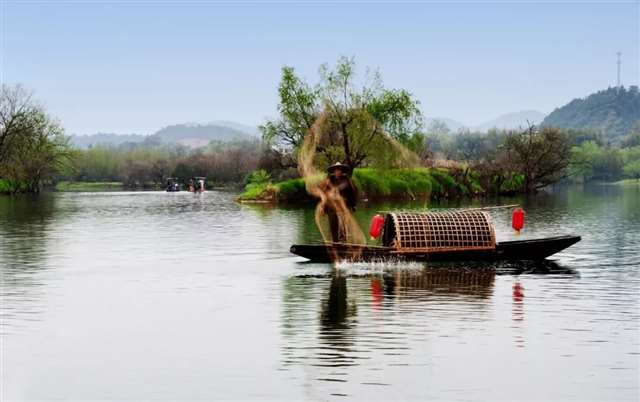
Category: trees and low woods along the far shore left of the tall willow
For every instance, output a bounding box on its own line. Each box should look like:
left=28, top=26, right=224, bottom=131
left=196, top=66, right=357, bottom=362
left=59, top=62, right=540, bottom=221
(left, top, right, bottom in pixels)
left=0, top=85, right=268, bottom=193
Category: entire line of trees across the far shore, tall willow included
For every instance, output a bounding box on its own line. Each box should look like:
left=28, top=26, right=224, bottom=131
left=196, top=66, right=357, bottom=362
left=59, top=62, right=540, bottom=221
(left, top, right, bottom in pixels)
left=0, top=57, right=640, bottom=193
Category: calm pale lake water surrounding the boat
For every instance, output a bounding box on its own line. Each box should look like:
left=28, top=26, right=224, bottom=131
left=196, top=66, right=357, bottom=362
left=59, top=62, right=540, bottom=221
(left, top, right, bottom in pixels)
left=0, top=185, right=640, bottom=401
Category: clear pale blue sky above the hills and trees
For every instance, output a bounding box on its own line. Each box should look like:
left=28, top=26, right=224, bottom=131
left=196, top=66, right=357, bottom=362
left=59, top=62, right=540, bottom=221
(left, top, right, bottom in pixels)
left=0, top=0, right=640, bottom=134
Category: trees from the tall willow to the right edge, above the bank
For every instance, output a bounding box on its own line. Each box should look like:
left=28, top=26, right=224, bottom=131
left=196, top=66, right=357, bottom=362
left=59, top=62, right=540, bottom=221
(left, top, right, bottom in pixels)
left=260, top=57, right=640, bottom=193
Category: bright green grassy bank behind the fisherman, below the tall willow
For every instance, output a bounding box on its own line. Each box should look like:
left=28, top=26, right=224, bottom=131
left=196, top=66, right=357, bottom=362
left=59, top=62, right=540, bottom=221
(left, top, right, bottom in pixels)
left=238, top=168, right=485, bottom=203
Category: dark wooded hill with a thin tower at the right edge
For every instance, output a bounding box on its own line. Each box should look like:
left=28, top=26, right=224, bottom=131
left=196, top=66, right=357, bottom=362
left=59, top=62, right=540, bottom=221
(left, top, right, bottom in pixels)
left=542, top=85, right=640, bottom=143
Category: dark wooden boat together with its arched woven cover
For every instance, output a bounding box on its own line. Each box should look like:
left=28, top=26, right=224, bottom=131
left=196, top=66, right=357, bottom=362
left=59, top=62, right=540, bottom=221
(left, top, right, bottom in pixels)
left=290, top=211, right=580, bottom=262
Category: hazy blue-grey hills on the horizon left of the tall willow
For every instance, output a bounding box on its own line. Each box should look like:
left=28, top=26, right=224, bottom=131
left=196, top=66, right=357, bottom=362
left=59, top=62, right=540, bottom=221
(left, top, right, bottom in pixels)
left=71, top=121, right=258, bottom=148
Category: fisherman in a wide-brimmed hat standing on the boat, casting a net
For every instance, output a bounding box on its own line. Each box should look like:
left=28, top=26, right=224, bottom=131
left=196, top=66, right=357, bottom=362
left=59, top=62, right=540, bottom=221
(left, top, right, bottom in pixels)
left=321, top=162, right=358, bottom=243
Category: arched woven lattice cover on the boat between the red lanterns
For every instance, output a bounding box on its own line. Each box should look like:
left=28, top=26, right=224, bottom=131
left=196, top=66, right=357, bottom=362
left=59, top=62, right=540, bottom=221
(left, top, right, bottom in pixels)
left=390, top=211, right=496, bottom=252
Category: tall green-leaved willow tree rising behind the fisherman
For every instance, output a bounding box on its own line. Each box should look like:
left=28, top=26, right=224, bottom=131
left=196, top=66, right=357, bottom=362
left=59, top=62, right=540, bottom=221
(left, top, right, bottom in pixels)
left=261, top=57, right=423, bottom=167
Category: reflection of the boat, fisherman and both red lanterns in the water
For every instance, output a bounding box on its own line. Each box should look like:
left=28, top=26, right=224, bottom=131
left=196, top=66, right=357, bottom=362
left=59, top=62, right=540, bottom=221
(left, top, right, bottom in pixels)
left=281, top=261, right=592, bottom=388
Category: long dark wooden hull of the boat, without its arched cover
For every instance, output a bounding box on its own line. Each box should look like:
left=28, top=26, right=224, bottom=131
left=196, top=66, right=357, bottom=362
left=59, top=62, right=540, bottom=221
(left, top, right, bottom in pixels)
left=290, top=236, right=581, bottom=262
